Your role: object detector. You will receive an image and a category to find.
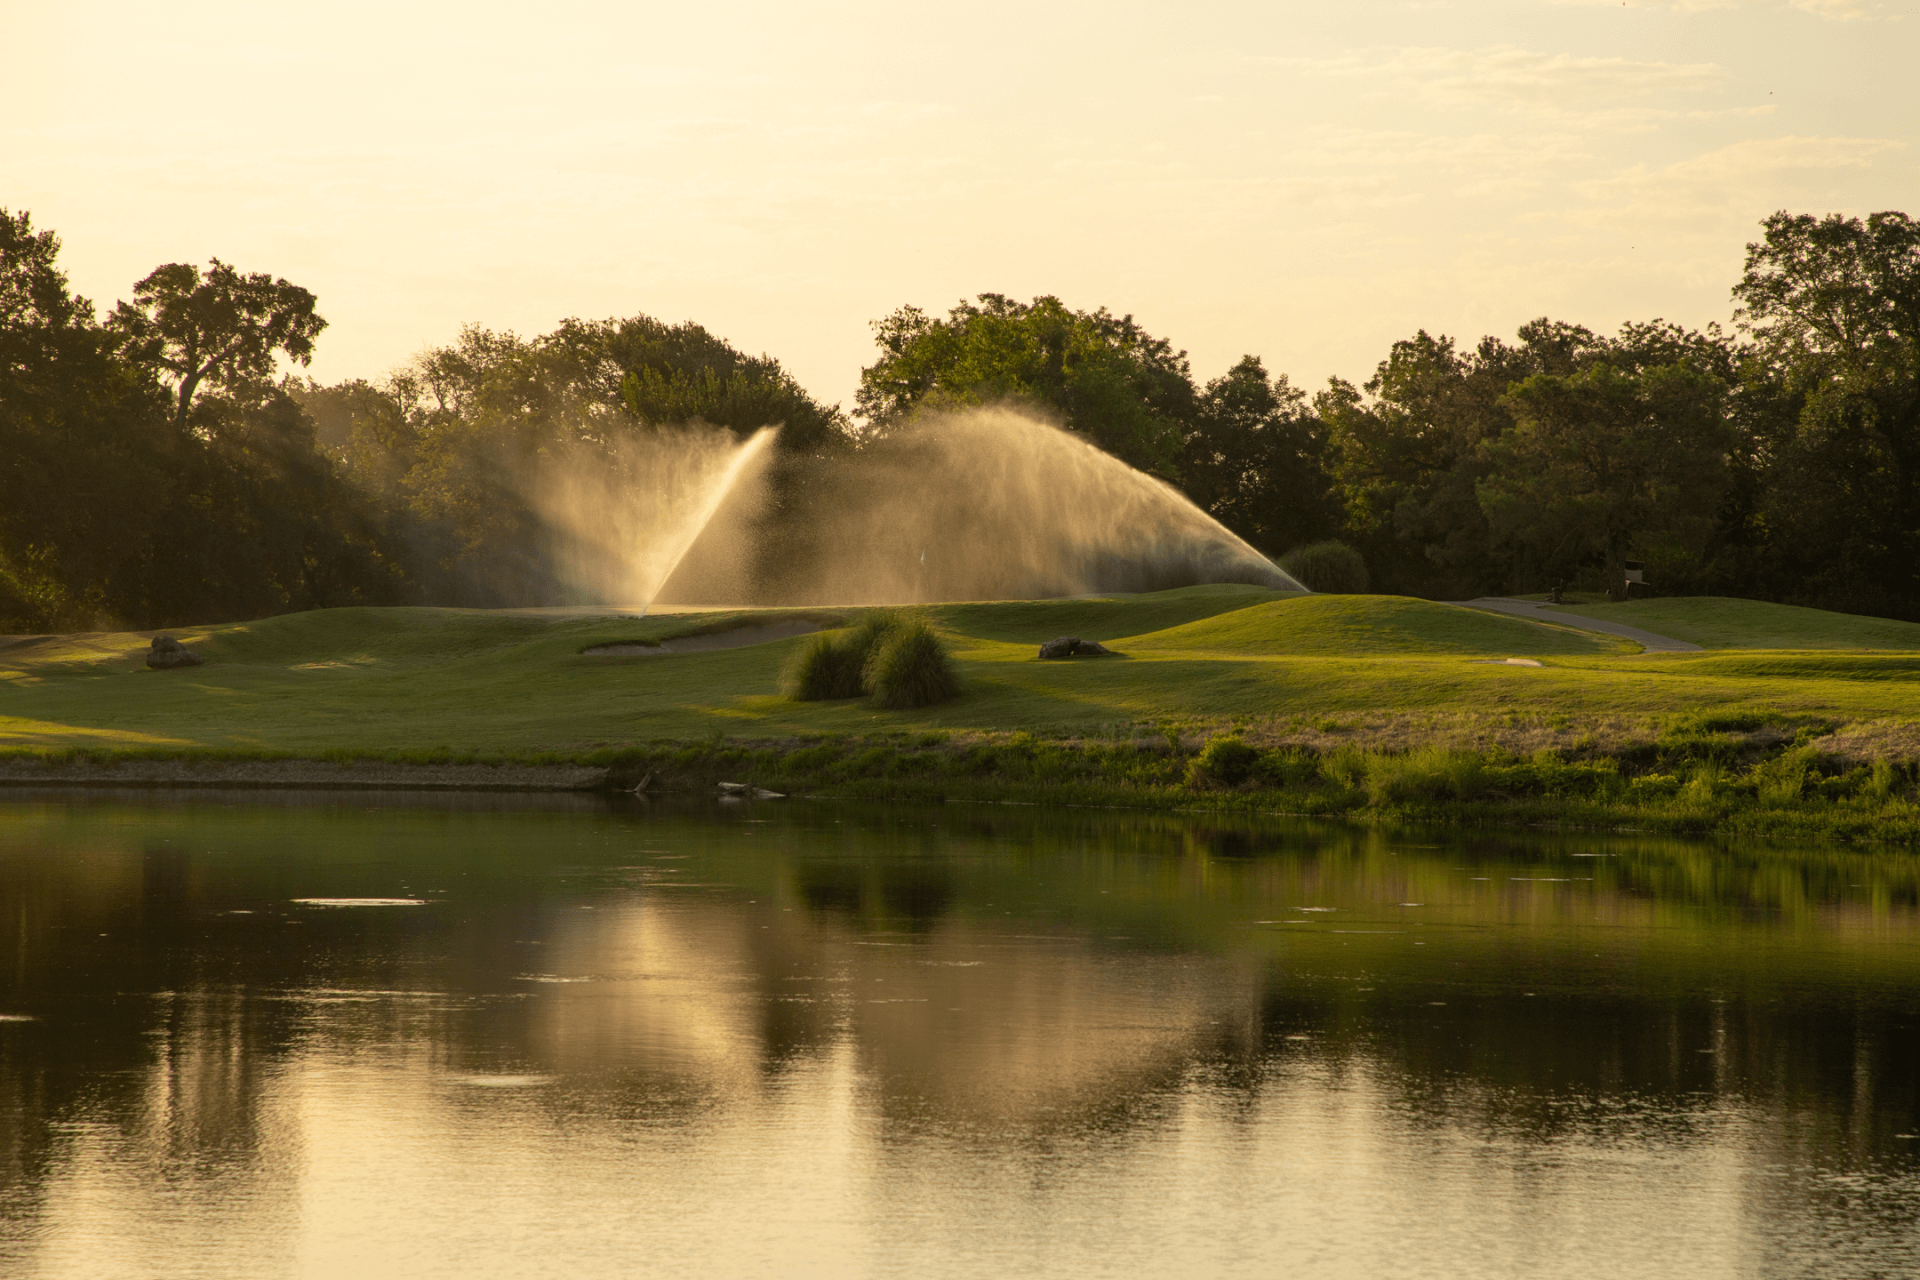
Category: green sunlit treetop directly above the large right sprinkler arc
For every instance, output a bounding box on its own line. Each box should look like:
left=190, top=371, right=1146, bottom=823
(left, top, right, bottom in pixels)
left=854, top=294, right=1194, bottom=478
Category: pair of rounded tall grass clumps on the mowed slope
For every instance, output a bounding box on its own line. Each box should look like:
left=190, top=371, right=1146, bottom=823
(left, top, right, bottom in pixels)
left=781, top=608, right=960, bottom=710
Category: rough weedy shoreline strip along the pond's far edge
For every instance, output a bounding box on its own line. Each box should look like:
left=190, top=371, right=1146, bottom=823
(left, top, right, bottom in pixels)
left=0, top=725, right=1920, bottom=854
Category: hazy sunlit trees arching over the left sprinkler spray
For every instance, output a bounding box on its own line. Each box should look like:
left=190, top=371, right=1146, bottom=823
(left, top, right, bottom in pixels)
left=298, top=317, right=845, bottom=604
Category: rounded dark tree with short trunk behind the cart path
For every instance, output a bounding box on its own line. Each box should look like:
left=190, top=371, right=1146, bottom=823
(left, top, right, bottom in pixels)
left=1475, top=361, right=1730, bottom=599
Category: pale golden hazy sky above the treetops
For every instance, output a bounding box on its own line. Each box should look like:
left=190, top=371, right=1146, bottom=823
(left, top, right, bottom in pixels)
left=0, top=0, right=1920, bottom=407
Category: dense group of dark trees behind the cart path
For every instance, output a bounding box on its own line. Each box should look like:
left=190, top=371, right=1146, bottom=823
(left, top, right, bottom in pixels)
left=1317, top=319, right=1734, bottom=599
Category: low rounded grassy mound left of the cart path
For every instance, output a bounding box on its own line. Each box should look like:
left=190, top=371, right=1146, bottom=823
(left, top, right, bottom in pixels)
left=1127, top=595, right=1638, bottom=658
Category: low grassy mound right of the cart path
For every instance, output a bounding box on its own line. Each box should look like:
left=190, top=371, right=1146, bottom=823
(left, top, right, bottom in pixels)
left=1548, top=595, right=1920, bottom=652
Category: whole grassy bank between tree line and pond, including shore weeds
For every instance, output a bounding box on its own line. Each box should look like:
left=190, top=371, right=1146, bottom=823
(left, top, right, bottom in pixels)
left=11, top=585, right=1920, bottom=842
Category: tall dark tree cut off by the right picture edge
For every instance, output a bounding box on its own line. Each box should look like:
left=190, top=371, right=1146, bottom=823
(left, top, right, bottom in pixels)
left=1734, top=211, right=1920, bottom=616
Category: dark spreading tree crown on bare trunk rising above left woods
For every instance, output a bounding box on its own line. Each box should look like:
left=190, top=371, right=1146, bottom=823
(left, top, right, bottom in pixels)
left=109, top=257, right=326, bottom=426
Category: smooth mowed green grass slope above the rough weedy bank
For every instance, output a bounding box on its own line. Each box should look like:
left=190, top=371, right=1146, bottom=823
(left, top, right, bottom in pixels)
left=0, top=585, right=1920, bottom=756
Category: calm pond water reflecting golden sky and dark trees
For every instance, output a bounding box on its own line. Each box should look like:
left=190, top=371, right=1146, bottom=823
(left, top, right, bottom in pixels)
left=0, top=794, right=1920, bottom=1278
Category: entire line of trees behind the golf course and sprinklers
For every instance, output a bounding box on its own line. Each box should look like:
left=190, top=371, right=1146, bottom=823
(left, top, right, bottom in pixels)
left=0, top=211, right=1920, bottom=629
